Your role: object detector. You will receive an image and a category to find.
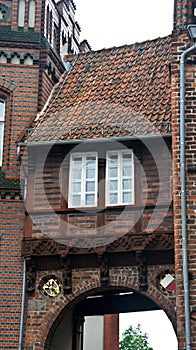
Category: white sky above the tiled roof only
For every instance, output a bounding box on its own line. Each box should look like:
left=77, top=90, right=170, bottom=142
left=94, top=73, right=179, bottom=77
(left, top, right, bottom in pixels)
left=74, top=0, right=174, bottom=50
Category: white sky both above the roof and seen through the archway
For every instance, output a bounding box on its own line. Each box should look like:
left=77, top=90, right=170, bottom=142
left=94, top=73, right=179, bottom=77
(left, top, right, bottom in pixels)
left=74, top=0, right=177, bottom=350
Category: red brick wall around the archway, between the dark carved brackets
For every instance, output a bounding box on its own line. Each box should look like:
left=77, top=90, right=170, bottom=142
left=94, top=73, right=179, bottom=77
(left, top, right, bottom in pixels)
left=24, top=265, right=175, bottom=350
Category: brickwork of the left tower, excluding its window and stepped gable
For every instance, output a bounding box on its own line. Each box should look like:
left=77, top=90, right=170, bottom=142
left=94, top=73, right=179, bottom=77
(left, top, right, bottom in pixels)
left=0, top=0, right=80, bottom=350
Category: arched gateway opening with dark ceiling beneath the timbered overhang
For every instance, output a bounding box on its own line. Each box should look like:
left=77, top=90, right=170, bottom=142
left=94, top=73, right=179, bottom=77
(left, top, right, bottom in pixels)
left=47, top=288, right=177, bottom=350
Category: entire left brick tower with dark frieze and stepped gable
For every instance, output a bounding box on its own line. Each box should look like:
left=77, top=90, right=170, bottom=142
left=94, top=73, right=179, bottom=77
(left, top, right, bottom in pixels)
left=0, top=0, right=83, bottom=349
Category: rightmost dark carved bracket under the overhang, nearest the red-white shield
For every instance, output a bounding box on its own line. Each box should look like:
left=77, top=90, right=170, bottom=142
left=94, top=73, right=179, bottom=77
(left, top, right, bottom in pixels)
left=135, top=251, right=148, bottom=291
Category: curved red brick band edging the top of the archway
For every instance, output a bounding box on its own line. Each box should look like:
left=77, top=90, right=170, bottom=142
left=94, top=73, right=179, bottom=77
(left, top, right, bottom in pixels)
left=35, top=276, right=176, bottom=350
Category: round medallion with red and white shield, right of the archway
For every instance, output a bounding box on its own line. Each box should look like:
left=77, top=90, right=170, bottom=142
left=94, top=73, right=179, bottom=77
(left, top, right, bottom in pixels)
left=157, top=270, right=176, bottom=295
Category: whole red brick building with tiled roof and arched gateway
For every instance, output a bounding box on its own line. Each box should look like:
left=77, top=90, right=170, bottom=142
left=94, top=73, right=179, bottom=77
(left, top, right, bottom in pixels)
left=0, top=0, right=196, bottom=350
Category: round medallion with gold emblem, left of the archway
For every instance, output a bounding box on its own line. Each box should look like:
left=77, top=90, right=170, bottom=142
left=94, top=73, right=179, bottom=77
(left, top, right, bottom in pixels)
left=38, top=275, right=62, bottom=298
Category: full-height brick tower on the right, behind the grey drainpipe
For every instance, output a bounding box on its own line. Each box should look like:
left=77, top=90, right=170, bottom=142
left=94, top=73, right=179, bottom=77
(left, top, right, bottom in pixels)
left=171, top=0, right=196, bottom=350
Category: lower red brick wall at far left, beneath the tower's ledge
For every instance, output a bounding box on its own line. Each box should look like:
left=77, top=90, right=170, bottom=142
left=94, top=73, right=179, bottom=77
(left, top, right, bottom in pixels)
left=0, top=199, right=24, bottom=349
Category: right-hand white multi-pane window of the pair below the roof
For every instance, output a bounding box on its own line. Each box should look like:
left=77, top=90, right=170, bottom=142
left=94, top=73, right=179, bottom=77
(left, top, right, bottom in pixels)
left=105, top=150, right=135, bottom=206
